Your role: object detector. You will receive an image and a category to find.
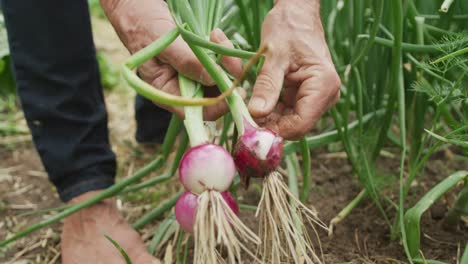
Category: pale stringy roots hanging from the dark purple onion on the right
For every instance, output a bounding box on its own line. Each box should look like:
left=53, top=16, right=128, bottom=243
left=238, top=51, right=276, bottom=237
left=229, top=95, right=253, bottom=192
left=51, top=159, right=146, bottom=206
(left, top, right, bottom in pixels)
left=256, top=171, right=327, bottom=264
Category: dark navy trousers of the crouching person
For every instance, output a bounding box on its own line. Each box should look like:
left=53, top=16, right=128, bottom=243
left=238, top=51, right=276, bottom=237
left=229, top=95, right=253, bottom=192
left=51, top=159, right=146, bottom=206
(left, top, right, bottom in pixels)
left=2, top=0, right=170, bottom=201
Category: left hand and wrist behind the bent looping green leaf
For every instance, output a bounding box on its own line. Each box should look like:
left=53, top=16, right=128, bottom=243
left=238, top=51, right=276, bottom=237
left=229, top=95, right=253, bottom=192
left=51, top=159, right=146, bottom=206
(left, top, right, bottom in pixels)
left=101, top=0, right=242, bottom=120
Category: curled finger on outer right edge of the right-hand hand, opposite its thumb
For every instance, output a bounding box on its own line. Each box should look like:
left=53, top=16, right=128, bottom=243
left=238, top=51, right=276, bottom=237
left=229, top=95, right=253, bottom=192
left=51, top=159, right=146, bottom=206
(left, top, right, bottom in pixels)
left=278, top=66, right=341, bottom=139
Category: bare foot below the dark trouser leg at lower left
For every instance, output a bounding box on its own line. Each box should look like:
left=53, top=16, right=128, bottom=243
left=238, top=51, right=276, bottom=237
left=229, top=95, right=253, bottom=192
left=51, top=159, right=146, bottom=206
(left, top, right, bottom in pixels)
left=61, top=191, right=161, bottom=264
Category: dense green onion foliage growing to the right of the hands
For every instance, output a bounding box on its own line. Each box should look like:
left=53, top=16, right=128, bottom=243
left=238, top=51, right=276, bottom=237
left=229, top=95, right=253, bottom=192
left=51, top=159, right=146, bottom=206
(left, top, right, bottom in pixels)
left=320, top=0, right=468, bottom=262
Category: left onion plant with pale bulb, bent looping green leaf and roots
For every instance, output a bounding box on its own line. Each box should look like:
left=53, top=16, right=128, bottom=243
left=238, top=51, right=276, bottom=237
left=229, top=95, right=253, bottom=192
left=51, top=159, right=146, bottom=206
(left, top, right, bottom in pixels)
left=118, top=1, right=260, bottom=263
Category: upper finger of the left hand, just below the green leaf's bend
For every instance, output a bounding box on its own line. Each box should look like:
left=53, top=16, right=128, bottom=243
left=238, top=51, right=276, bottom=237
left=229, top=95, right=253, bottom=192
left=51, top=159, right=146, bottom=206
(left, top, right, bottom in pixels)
left=158, top=37, right=215, bottom=86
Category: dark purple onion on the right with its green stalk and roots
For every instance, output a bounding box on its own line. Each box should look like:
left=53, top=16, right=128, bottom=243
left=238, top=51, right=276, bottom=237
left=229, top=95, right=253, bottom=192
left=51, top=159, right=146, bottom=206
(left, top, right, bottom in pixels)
left=168, top=0, right=327, bottom=263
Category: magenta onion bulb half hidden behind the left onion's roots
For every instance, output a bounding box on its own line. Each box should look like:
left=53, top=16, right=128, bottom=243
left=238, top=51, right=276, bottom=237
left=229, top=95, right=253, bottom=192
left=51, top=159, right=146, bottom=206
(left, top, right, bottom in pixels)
left=175, top=192, right=239, bottom=234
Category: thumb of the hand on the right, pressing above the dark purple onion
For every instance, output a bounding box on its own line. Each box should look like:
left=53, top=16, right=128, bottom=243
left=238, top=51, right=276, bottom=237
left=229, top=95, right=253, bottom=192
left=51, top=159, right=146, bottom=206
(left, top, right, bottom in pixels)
left=249, top=57, right=284, bottom=118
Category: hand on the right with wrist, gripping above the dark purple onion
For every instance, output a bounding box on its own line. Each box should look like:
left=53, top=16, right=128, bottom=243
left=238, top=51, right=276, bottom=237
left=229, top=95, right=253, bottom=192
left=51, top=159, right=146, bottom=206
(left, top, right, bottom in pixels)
left=249, top=0, right=340, bottom=139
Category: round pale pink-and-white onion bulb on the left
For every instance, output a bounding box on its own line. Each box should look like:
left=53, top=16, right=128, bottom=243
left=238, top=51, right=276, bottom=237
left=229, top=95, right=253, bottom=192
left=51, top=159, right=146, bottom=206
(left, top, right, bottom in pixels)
left=179, top=144, right=236, bottom=194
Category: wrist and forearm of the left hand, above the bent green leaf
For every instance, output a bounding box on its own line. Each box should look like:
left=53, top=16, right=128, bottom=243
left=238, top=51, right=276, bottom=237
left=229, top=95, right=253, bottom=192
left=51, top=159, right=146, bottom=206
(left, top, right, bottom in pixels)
left=101, top=0, right=175, bottom=53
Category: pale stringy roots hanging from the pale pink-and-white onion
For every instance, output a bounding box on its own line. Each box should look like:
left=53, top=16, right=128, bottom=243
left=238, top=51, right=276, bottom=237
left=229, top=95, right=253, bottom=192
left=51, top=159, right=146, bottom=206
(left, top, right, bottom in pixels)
left=194, top=191, right=260, bottom=264
